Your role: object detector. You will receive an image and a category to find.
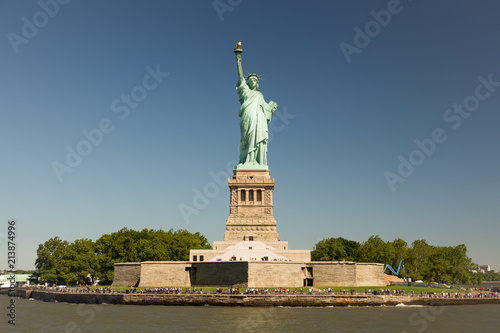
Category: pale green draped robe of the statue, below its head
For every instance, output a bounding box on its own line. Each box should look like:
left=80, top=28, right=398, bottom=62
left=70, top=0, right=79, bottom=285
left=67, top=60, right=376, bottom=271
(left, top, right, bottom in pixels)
left=236, top=80, right=272, bottom=166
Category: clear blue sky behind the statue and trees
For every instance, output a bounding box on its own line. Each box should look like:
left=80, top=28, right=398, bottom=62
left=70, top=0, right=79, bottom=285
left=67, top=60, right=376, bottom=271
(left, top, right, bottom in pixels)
left=0, top=0, right=500, bottom=269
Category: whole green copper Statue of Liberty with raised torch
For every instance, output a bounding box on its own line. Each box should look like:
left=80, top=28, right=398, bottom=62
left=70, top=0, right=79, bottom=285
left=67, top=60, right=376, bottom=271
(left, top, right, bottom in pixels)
left=234, top=43, right=278, bottom=170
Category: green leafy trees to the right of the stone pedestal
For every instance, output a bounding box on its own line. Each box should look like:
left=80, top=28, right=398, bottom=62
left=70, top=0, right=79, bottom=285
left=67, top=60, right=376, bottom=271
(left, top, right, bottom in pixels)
left=311, top=236, right=485, bottom=285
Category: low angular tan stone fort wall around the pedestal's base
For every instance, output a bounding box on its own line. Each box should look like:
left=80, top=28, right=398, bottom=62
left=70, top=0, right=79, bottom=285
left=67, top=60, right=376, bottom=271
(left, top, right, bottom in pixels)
left=113, top=261, right=385, bottom=288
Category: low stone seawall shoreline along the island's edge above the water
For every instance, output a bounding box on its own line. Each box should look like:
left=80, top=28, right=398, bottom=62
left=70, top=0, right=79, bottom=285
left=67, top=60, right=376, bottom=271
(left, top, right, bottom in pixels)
left=4, top=289, right=500, bottom=307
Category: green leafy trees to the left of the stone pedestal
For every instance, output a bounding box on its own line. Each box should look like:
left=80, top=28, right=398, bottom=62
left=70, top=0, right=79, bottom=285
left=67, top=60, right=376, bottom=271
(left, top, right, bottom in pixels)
left=35, top=228, right=212, bottom=285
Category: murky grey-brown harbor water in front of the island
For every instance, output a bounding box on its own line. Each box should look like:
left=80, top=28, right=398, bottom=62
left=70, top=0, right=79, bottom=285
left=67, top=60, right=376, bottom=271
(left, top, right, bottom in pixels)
left=0, top=295, right=500, bottom=333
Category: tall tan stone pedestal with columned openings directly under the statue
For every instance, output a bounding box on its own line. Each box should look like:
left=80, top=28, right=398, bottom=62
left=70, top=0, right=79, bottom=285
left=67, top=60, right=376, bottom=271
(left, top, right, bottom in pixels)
left=224, top=170, right=279, bottom=242
